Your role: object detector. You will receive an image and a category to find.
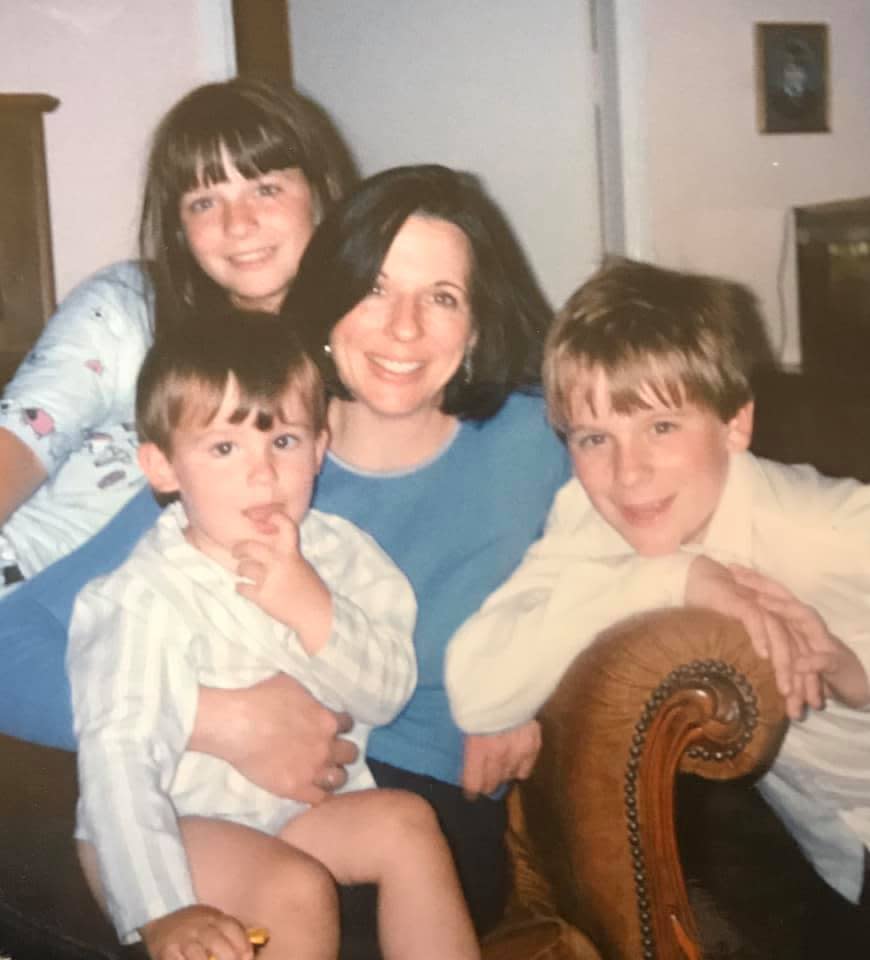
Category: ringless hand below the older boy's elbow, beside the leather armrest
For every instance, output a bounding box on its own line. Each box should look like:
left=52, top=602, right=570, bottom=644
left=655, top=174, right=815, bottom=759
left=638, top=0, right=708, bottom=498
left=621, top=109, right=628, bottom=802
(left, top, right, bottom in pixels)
left=462, top=720, right=541, bottom=799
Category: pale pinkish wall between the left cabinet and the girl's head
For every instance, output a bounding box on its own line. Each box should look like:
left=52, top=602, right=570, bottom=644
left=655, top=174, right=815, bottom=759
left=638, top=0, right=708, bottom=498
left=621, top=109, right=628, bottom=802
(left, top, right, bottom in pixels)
left=0, top=0, right=234, bottom=297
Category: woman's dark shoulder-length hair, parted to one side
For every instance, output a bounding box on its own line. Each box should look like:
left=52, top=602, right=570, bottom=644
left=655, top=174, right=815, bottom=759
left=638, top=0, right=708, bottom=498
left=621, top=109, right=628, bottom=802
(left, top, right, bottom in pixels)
left=288, top=165, right=551, bottom=420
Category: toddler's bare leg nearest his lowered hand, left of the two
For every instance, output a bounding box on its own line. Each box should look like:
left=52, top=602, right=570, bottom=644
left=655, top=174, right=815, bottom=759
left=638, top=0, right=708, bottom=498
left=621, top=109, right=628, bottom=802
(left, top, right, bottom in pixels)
left=180, top=817, right=339, bottom=960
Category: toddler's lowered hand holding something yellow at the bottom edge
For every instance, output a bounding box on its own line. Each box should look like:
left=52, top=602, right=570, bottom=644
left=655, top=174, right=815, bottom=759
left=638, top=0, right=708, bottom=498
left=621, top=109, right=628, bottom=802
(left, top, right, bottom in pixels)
left=139, top=904, right=254, bottom=960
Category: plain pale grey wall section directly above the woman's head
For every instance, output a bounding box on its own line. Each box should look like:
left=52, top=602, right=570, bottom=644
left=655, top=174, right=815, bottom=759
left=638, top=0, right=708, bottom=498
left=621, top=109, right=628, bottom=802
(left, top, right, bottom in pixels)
left=290, top=0, right=602, bottom=305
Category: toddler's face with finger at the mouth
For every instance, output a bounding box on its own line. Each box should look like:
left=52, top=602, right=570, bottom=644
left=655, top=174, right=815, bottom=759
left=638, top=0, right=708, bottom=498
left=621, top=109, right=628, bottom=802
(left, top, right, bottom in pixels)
left=143, top=378, right=327, bottom=570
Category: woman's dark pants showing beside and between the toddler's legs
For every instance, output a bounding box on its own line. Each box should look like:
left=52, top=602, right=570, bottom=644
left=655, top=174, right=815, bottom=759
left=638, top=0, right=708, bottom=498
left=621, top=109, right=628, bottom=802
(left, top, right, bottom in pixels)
left=339, top=759, right=508, bottom=960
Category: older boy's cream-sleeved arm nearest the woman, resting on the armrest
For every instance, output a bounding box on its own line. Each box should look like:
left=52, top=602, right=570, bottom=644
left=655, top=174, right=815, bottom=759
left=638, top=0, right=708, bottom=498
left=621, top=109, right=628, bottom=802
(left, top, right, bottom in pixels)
left=445, top=485, right=693, bottom=733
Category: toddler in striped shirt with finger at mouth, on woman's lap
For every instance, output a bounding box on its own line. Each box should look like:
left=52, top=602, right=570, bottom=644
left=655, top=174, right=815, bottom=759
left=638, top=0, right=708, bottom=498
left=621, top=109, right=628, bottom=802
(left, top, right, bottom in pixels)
left=68, top=313, right=479, bottom=960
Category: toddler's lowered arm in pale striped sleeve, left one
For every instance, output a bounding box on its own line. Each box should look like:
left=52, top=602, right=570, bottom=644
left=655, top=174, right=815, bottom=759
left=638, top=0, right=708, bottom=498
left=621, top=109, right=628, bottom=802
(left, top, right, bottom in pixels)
left=67, top=587, right=196, bottom=942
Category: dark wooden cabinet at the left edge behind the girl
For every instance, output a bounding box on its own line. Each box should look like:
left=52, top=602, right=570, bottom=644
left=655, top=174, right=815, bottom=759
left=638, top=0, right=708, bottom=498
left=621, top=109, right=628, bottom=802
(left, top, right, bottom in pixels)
left=0, top=93, right=58, bottom=385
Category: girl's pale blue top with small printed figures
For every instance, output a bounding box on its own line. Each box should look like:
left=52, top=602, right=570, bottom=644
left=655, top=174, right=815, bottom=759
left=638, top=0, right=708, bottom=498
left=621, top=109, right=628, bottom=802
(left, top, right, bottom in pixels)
left=0, top=263, right=152, bottom=576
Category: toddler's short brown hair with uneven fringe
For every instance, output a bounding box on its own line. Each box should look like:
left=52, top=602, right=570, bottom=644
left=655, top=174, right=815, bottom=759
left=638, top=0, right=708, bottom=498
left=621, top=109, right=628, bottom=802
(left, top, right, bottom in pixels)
left=136, top=307, right=326, bottom=456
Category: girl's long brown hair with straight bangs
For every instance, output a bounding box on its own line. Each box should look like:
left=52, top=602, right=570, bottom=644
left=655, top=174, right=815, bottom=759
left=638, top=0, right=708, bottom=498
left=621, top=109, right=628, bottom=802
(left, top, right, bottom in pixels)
left=139, top=78, right=356, bottom=340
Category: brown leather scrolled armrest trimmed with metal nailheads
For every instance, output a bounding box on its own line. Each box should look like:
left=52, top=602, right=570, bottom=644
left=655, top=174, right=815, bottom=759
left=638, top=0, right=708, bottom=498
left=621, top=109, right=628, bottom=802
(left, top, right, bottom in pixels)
left=512, top=609, right=786, bottom=960
